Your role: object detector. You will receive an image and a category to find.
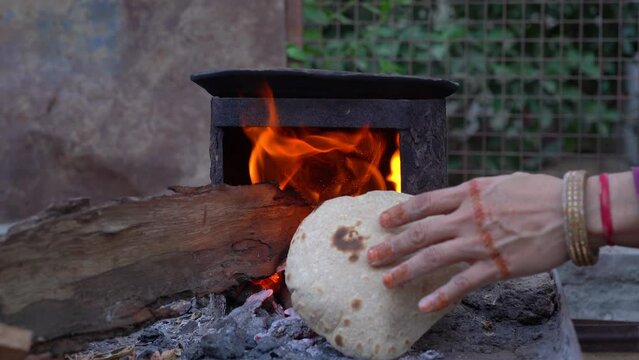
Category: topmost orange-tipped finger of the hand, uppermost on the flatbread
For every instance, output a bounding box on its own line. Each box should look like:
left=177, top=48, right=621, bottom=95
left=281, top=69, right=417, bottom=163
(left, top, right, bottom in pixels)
left=379, top=184, right=467, bottom=228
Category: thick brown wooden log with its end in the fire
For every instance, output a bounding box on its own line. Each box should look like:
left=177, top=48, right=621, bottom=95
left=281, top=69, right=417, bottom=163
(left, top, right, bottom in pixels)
left=0, top=184, right=311, bottom=352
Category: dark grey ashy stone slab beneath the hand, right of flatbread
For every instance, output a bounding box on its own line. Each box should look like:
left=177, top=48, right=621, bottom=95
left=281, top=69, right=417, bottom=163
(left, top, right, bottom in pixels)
left=415, top=272, right=581, bottom=360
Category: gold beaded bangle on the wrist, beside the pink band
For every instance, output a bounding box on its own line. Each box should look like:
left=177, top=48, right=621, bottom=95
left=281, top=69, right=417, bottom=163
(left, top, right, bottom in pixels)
left=561, top=170, right=599, bottom=266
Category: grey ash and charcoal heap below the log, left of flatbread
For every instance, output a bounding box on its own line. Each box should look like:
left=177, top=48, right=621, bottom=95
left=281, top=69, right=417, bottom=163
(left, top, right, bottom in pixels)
left=83, top=290, right=441, bottom=360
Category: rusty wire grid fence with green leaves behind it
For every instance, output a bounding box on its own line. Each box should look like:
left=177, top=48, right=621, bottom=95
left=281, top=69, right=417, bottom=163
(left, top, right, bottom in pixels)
left=298, top=0, right=639, bottom=185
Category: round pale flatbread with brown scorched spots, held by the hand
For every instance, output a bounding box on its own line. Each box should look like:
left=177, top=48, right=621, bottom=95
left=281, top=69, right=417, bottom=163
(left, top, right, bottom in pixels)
left=286, top=191, right=462, bottom=359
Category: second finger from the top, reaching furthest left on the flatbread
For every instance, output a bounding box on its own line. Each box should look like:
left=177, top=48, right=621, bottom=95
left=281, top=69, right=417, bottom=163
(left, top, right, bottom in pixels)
left=367, top=215, right=457, bottom=266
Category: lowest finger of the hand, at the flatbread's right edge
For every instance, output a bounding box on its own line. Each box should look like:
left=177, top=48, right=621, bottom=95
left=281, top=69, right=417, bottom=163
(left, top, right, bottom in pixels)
left=419, top=261, right=499, bottom=312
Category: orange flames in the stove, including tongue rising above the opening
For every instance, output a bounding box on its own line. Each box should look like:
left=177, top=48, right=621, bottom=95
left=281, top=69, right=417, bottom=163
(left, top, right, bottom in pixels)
left=244, top=86, right=401, bottom=204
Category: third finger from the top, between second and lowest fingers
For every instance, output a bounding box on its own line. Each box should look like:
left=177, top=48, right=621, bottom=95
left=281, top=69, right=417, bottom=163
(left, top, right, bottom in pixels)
left=382, top=239, right=481, bottom=288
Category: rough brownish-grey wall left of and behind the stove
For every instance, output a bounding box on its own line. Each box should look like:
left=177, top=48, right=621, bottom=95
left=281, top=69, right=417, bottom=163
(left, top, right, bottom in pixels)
left=0, top=0, right=285, bottom=222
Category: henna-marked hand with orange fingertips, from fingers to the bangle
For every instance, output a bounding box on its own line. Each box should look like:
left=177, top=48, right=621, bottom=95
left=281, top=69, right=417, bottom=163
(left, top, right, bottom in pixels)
left=368, top=173, right=568, bottom=312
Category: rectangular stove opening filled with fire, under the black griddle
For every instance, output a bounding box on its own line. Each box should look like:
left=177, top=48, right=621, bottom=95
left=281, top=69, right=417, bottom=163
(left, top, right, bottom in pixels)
left=223, top=127, right=401, bottom=204
